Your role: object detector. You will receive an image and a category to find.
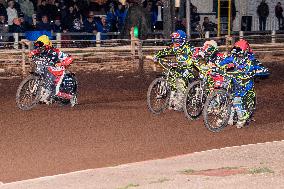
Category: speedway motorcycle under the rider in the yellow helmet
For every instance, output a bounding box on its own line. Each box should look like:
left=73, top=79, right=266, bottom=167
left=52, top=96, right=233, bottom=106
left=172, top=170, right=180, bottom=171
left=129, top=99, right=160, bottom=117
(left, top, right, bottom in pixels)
left=16, top=56, right=78, bottom=110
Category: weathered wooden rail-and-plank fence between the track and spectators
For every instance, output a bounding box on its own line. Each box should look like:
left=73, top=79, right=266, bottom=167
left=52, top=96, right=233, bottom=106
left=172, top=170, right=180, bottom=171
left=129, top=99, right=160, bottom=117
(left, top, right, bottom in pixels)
left=0, top=31, right=284, bottom=78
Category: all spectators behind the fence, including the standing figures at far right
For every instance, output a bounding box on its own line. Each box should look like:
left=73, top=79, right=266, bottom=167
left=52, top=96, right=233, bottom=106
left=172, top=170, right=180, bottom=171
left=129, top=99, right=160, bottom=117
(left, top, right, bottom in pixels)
left=0, top=0, right=284, bottom=41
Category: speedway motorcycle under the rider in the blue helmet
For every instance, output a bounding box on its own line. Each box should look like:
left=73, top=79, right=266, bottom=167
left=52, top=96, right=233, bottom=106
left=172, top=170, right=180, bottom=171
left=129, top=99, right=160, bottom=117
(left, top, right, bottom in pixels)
left=147, top=58, right=193, bottom=114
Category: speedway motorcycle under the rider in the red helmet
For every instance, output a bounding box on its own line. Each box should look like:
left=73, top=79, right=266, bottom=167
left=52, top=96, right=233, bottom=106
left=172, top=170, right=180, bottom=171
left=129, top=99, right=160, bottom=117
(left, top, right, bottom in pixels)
left=203, top=75, right=256, bottom=132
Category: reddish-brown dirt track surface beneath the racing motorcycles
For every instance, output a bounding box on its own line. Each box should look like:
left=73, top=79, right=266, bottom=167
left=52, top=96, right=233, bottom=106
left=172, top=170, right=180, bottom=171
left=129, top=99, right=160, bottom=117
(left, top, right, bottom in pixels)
left=0, top=63, right=284, bottom=183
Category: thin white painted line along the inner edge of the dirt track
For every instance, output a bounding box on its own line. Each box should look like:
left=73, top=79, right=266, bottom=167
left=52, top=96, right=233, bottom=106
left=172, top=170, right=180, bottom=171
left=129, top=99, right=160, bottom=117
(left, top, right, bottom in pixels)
left=0, top=140, right=284, bottom=186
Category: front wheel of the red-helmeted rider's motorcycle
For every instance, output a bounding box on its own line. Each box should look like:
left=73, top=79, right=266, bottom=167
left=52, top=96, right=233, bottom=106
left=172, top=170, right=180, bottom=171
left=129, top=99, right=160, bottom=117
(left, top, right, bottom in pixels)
left=203, top=89, right=232, bottom=132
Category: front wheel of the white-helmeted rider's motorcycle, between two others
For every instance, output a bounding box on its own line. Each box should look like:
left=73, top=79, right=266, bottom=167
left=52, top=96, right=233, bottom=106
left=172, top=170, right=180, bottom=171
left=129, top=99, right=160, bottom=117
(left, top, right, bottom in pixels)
left=183, top=80, right=206, bottom=120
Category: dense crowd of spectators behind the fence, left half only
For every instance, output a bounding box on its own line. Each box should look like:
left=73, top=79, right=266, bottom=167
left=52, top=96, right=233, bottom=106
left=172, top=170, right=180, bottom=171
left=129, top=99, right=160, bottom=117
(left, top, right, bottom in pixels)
left=0, top=0, right=168, bottom=38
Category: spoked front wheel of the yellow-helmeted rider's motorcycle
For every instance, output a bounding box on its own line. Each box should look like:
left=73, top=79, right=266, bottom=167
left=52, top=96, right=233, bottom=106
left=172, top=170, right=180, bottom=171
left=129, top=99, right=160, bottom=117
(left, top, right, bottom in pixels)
left=16, top=75, right=40, bottom=110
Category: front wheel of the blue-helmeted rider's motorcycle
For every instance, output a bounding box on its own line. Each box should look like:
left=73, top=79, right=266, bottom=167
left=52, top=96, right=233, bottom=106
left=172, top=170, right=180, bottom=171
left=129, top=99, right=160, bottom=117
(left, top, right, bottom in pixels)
left=147, top=77, right=170, bottom=114
